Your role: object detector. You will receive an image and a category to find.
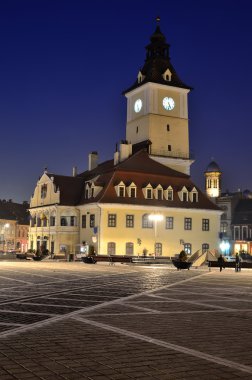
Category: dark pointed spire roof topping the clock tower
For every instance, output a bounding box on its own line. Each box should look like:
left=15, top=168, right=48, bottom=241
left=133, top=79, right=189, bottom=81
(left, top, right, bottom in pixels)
left=124, top=17, right=191, bottom=93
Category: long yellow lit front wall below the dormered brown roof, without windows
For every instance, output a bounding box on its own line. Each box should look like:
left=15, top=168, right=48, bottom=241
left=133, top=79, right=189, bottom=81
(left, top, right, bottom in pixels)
left=80, top=204, right=220, bottom=256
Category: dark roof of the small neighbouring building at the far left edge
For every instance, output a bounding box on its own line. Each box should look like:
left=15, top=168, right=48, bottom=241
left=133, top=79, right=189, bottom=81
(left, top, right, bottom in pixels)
left=0, top=200, right=29, bottom=224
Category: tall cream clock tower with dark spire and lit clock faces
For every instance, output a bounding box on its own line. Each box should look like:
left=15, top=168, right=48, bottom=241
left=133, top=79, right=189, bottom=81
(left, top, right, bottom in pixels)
left=124, top=18, right=193, bottom=174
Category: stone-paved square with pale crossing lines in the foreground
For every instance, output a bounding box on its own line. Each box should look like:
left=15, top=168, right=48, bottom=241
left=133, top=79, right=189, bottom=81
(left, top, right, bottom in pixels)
left=0, top=261, right=252, bottom=380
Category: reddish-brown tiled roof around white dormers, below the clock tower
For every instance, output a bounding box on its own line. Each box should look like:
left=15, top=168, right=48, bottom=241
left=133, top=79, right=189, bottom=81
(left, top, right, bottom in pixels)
left=80, top=150, right=219, bottom=210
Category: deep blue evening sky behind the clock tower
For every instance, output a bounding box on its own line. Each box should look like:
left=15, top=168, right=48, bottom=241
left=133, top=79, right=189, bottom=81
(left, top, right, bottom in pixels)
left=0, top=0, right=252, bottom=202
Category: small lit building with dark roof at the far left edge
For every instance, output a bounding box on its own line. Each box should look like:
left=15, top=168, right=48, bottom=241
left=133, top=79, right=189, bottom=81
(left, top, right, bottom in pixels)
left=0, top=199, right=29, bottom=252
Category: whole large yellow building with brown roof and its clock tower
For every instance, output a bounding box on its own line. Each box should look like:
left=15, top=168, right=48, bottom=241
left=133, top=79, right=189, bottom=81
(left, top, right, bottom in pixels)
left=29, top=19, right=221, bottom=256
